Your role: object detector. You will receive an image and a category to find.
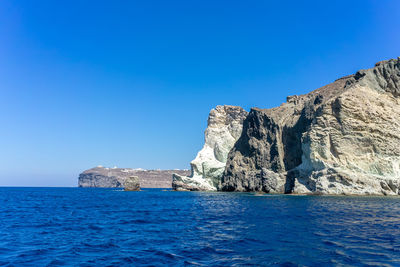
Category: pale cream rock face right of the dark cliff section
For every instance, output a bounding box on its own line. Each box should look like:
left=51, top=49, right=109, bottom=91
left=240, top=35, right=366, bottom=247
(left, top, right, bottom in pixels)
left=293, top=60, right=400, bottom=195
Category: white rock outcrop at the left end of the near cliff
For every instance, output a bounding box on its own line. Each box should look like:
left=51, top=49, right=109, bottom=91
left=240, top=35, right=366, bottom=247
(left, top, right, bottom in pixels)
left=172, top=105, right=247, bottom=191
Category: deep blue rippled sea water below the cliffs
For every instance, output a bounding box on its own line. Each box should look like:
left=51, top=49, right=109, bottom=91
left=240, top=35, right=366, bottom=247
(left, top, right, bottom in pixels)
left=0, top=188, right=400, bottom=266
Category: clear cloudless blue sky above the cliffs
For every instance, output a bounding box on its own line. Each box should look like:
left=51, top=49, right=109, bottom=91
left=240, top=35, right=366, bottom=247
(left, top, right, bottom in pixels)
left=0, top=0, right=400, bottom=186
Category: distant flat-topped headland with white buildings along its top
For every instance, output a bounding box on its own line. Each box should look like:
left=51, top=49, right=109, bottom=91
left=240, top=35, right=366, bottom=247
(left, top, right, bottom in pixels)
left=78, top=167, right=190, bottom=188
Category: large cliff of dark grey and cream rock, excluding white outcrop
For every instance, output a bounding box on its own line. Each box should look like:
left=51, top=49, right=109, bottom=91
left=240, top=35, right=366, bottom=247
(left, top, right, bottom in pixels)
left=221, top=58, right=400, bottom=195
